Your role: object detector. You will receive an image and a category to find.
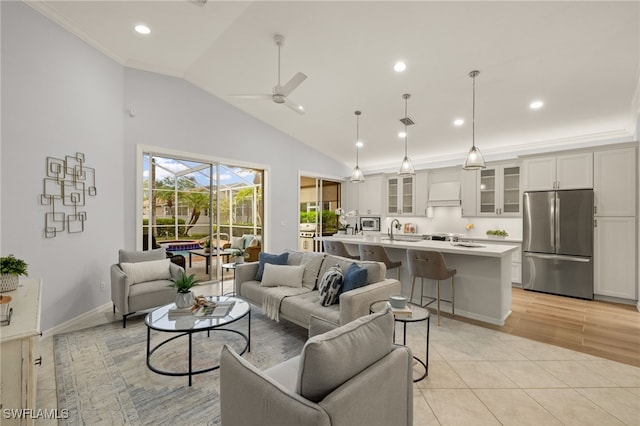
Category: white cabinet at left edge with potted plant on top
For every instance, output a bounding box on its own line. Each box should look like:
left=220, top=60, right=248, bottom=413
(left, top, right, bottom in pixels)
left=0, top=279, right=42, bottom=425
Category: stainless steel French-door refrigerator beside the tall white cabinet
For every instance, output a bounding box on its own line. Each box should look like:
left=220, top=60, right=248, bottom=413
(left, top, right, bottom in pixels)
left=522, top=189, right=593, bottom=299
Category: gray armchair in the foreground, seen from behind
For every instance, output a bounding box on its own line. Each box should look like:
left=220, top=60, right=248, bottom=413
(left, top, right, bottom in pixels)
left=220, top=310, right=413, bottom=426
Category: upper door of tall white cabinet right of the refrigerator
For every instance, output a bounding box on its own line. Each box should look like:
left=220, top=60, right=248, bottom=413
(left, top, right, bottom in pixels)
left=593, top=148, right=637, bottom=216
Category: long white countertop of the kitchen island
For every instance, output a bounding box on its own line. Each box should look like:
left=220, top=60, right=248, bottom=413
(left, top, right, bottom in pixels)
left=322, top=235, right=519, bottom=257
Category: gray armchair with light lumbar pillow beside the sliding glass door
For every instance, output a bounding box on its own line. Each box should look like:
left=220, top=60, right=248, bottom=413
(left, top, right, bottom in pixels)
left=111, top=248, right=184, bottom=328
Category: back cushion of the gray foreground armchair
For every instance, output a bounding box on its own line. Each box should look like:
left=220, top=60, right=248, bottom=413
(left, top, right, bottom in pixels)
left=296, top=309, right=394, bottom=402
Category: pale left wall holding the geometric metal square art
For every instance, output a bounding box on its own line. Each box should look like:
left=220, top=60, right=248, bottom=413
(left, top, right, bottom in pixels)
left=1, top=2, right=124, bottom=329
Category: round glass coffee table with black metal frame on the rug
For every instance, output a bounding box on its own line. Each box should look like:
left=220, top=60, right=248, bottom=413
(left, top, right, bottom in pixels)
left=144, top=296, right=251, bottom=386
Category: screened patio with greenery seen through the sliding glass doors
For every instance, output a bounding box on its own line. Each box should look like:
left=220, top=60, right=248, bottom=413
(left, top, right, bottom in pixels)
left=141, top=153, right=264, bottom=281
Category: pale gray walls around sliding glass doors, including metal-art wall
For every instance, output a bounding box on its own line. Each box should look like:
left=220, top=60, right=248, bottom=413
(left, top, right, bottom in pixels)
left=0, top=2, right=349, bottom=330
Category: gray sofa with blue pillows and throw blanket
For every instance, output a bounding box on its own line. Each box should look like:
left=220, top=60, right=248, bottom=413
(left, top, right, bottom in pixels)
left=235, top=251, right=400, bottom=329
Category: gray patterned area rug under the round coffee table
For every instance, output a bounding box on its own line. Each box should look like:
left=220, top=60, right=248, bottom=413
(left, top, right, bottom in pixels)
left=53, top=309, right=307, bottom=425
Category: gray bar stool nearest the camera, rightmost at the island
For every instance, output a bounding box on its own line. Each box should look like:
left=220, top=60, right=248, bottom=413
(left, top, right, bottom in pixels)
left=407, top=249, right=456, bottom=325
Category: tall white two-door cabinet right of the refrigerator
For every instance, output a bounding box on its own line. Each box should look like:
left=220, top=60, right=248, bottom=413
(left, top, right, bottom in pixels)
left=593, top=148, right=638, bottom=300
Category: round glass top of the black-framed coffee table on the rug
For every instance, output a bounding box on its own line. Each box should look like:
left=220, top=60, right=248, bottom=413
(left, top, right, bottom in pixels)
left=144, top=296, right=251, bottom=332
